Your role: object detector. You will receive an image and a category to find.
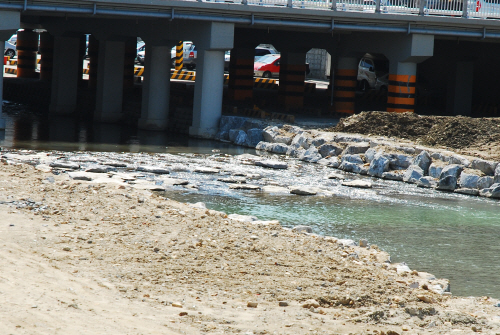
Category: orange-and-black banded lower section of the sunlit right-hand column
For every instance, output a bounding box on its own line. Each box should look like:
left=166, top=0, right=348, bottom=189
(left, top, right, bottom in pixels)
left=387, top=74, right=417, bottom=113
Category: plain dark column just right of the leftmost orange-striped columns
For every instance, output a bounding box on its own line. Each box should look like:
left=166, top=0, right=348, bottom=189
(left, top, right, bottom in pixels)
left=49, top=36, right=80, bottom=114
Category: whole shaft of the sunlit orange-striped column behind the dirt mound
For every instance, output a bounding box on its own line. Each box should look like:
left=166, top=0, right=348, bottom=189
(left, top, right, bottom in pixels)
left=387, top=60, right=417, bottom=113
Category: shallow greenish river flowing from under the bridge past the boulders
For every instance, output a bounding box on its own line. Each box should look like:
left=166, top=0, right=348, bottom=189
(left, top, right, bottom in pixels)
left=0, top=105, right=500, bottom=298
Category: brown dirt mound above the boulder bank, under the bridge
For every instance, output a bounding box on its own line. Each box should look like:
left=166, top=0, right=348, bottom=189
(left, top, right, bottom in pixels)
left=331, top=112, right=500, bottom=159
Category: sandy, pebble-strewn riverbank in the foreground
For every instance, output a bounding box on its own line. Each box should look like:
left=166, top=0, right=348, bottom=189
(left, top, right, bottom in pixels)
left=0, top=153, right=500, bottom=334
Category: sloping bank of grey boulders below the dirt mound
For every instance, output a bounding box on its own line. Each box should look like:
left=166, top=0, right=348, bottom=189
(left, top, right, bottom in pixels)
left=217, top=116, right=500, bottom=199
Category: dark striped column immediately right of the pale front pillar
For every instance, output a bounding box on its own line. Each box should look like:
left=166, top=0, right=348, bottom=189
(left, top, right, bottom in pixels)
left=228, top=47, right=255, bottom=101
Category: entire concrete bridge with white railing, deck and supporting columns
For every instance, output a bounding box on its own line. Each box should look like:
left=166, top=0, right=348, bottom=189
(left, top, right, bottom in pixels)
left=0, top=0, right=500, bottom=138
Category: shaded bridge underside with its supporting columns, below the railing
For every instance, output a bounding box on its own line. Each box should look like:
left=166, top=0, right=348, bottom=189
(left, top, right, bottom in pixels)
left=0, top=4, right=500, bottom=134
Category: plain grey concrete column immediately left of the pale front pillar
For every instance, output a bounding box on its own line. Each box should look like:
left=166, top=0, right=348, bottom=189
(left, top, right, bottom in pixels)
left=139, top=43, right=172, bottom=130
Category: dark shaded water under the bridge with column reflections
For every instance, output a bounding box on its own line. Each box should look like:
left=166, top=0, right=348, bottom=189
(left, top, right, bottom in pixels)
left=0, top=108, right=253, bottom=154
